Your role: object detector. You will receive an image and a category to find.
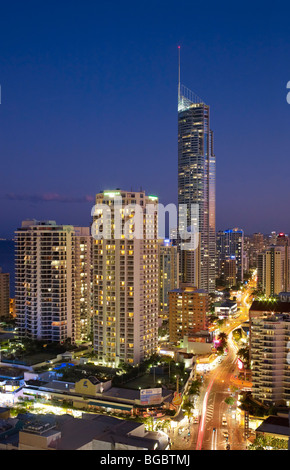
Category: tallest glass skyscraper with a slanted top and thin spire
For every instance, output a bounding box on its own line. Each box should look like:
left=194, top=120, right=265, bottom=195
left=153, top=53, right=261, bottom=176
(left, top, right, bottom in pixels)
left=178, top=51, right=216, bottom=292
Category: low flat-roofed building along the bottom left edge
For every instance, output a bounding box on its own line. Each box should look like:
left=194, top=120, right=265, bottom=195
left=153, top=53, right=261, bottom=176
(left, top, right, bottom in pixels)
left=0, top=413, right=170, bottom=451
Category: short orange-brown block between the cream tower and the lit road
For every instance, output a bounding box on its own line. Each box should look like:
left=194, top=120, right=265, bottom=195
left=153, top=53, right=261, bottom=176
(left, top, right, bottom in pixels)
left=169, top=284, right=209, bottom=343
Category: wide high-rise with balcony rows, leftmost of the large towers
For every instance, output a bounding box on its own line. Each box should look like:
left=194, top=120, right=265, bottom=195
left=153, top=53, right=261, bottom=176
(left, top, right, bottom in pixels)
left=15, top=220, right=89, bottom=343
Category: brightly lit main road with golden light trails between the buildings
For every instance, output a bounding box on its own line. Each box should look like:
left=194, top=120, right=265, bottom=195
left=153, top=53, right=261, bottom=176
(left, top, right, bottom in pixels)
left=172, top=280, right=255, bottom=450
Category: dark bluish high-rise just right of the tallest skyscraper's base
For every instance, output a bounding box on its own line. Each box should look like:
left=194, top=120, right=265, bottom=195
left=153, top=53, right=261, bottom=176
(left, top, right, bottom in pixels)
left=216, top=228, right=244, bottom=282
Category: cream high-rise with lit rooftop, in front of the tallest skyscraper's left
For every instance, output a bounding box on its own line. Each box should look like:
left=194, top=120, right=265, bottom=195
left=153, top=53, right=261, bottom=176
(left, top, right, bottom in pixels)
left=92, top=190, right=159, bottom=365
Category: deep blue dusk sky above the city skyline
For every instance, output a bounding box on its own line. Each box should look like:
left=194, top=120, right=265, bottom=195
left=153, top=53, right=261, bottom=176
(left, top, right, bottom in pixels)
left=0, top=0, right=290, bottom=237
